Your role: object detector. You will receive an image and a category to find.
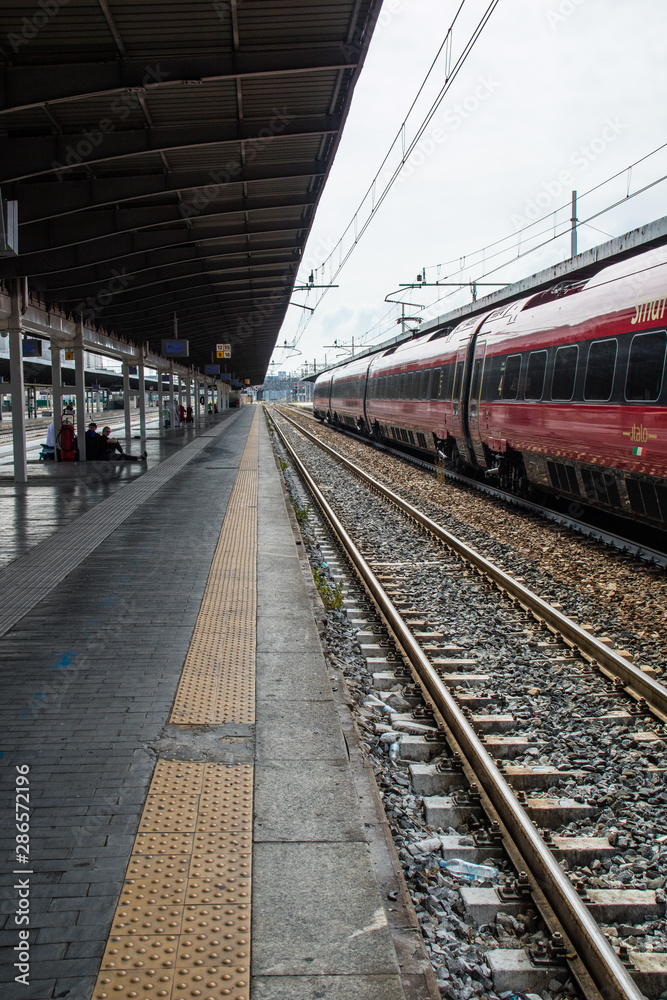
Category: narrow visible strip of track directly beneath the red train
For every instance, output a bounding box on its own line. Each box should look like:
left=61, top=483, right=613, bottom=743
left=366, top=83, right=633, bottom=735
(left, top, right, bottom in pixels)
left=288, top=408, right=667, bottom=568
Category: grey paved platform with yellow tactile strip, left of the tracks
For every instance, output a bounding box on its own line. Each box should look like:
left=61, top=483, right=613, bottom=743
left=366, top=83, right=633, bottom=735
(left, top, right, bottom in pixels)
left=0, top=406, right=437, bottom=1000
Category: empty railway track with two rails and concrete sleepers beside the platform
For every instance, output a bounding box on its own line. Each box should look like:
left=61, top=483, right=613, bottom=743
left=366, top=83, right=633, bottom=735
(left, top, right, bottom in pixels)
left=268, top=404, right=667, bottom=1000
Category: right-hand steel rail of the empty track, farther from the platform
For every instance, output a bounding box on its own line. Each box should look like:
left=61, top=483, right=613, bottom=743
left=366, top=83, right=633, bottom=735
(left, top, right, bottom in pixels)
left=282, top=413, right=667, bottom=722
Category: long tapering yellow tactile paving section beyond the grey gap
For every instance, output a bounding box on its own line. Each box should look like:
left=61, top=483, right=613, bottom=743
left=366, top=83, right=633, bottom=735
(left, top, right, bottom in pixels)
left=169, top=414, right=259, bottom=725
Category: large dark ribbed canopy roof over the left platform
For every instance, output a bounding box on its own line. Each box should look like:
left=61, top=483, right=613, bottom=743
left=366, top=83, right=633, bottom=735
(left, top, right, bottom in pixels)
left=0, top=0, right=381, bottom=383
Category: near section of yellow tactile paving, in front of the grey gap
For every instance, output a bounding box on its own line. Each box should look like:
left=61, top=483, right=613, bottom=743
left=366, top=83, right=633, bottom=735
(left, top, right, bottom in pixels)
left=93, top=760, right=253, bottom=1000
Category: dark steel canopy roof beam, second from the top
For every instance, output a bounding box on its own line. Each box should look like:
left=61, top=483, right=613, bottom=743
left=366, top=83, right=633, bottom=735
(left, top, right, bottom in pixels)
left=0, top=119, right=341, bottom=183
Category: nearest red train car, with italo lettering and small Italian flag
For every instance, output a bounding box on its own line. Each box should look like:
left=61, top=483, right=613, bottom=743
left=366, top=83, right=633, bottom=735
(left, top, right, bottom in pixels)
left=466, top=248, right=667, bottom=523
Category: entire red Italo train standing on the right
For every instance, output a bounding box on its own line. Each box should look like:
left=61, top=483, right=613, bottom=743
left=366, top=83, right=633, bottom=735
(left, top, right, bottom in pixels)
left=313, top=247, right=667, bottom=527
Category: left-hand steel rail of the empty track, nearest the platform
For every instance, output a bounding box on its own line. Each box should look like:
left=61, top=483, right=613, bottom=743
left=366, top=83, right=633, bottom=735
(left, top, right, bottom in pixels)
left=273, top=408, right=644, bottom=1000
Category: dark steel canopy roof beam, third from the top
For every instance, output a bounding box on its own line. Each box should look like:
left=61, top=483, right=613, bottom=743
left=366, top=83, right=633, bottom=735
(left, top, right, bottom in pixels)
left=14, top=160, right=327, bottom=222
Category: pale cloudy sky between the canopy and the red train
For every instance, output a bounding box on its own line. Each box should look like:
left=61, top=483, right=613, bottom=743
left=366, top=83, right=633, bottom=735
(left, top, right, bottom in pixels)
left=270, top=0, right=667, bottom=372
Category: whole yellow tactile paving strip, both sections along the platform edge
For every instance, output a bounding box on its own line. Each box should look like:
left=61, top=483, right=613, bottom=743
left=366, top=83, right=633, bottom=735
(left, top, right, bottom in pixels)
left=93, top=415, right=259, bottom=1000
